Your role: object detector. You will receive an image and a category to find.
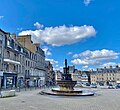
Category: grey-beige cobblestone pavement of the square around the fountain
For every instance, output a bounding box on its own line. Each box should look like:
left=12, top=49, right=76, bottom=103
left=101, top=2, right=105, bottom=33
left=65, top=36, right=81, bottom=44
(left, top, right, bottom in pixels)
left=0, top=89, right=120, bottom=110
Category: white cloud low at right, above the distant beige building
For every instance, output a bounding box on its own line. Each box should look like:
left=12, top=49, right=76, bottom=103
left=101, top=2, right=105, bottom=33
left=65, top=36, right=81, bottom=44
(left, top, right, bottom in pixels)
left=71, top=49, right=119, bottom=65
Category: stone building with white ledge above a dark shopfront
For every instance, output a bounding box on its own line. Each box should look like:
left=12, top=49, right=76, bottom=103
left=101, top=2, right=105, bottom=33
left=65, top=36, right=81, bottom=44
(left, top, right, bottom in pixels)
left=1, top=33, right=20, bottom=88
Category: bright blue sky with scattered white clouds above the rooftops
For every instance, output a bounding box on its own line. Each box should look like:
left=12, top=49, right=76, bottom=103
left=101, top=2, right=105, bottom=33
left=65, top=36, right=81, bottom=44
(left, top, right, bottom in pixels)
left=0, top=0, right=120, bottom=70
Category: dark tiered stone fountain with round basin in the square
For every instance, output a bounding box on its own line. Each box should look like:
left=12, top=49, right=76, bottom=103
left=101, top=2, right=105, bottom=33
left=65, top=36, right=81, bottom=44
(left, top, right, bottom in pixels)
left=40, top=59, right=94, bottom=96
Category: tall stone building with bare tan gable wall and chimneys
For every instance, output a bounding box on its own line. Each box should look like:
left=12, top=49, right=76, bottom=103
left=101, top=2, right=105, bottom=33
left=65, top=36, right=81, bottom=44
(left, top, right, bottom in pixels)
left=17, top=35, right=46, bottom=86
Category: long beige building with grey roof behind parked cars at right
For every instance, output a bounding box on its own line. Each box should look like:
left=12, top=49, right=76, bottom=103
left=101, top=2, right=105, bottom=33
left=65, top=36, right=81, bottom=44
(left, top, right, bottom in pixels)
left=91, top=66, right=120, bottom=85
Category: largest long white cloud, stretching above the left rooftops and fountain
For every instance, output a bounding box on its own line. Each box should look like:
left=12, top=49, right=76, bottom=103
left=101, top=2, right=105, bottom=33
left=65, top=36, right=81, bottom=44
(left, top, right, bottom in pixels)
left=19, top=25, right=96, bottom=46
